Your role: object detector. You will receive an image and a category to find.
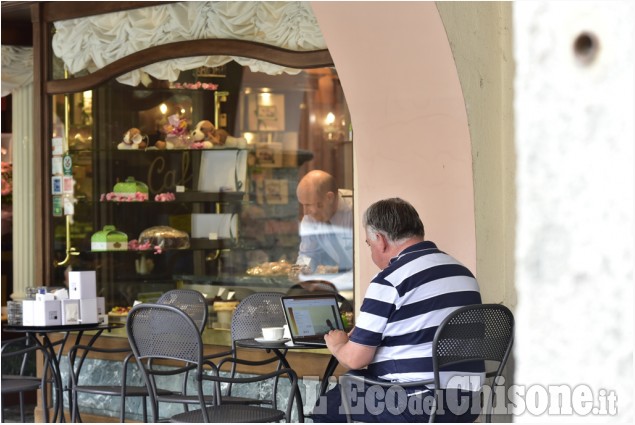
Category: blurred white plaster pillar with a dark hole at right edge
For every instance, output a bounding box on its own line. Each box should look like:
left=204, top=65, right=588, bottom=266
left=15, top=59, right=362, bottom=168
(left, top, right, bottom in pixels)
left=513, top=1, right=635, bottom=423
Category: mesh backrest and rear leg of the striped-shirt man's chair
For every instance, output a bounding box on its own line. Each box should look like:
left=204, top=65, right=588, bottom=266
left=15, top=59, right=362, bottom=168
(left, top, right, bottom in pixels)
left=432, top=304, right=514, bottom=422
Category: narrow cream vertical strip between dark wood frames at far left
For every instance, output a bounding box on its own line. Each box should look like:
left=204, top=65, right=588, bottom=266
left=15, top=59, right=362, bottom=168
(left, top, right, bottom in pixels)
left=11, top=84, right=36, bottom=300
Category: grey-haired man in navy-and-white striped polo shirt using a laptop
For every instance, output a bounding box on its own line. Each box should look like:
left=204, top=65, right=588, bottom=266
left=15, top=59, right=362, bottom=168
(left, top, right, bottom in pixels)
left=313, top=198, right=483, bottom=422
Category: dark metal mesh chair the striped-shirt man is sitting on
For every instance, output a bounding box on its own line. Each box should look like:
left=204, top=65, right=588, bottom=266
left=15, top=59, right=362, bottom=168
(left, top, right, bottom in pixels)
left=340, top=304, right=514, bottom=422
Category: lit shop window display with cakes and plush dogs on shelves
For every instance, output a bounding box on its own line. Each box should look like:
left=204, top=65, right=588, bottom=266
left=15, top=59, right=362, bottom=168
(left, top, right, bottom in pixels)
left=45, top=38, right=352, bottom=308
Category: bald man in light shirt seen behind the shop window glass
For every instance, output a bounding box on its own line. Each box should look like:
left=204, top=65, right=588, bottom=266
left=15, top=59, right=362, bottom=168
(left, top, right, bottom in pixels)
left=296, top=170, right=353, bottom=289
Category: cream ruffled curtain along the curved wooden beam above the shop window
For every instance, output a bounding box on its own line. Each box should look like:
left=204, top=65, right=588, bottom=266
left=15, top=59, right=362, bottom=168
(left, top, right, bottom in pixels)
left=53, top=1, right=326, bottom=86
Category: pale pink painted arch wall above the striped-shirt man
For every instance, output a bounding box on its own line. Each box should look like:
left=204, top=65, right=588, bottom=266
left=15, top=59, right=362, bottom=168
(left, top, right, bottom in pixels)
left=311, top=2, right=476, bottom=296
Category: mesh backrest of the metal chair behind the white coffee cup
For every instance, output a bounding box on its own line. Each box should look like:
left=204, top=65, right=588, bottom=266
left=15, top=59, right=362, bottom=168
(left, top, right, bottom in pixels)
left=231, top=292, right=287, bottom=341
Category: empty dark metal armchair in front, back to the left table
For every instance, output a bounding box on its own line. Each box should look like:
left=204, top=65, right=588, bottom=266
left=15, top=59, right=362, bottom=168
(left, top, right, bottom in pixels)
left=126, top=304, right=299, bottom=423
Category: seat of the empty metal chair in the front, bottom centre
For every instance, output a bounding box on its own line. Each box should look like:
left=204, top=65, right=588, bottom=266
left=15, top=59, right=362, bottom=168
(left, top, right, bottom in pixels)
left=170, top=404, right=284, bottom=423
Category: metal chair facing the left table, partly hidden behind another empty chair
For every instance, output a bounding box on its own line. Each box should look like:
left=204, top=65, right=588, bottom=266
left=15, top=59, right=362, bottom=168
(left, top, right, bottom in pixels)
left=68, top=289, right=208, bottom=422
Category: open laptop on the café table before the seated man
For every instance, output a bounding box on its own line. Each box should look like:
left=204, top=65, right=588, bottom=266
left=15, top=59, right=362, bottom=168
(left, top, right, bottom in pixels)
left=281, top=294, right=344, bottom=347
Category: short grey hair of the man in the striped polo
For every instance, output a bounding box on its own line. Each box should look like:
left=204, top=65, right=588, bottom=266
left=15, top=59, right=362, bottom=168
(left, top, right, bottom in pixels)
left=364, top=198, right=425, bottom=242
